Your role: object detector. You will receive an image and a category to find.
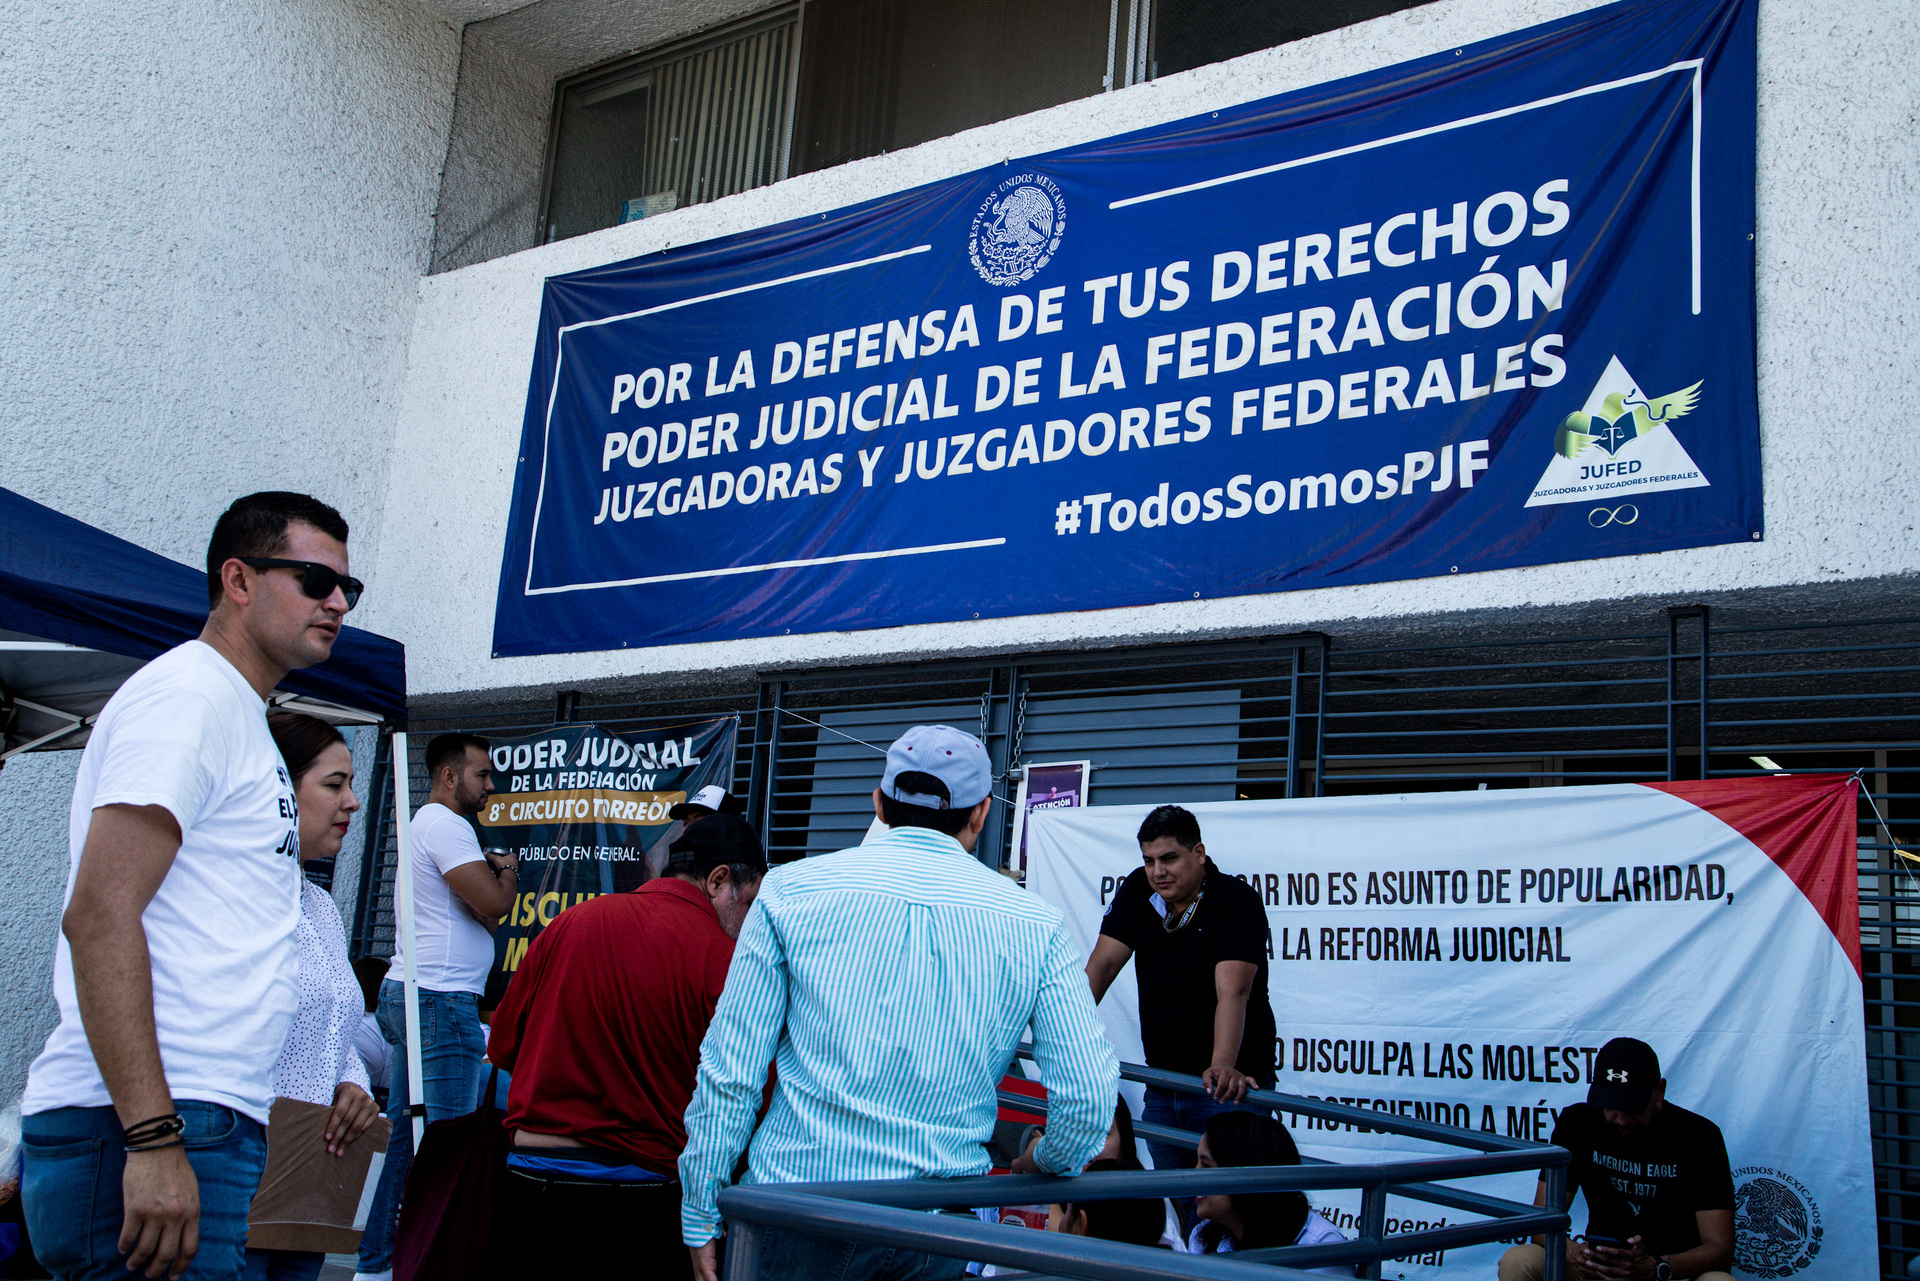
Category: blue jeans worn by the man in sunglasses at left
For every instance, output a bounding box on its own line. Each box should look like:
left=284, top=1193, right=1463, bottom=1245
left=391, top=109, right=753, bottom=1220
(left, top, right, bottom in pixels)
left=21, top=1099, right=267, bottom=1281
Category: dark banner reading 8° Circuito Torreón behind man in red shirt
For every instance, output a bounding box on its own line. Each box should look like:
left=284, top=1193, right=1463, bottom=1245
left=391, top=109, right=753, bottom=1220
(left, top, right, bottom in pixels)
left=478, top=716, right=739, bottom=999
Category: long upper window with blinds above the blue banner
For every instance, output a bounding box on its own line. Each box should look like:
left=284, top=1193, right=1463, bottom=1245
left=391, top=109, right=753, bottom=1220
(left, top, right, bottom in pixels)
left=540, top=0, right=1427, bottom=240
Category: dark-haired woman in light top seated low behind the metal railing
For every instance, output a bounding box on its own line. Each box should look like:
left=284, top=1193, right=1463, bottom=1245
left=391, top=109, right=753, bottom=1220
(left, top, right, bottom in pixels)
left=1187, top=1112, right=1357, bottom=1277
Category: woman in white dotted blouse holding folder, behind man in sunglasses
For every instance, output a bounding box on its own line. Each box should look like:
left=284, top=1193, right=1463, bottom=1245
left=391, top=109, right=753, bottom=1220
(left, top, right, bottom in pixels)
left=246, top=713, right=380, bottom=1281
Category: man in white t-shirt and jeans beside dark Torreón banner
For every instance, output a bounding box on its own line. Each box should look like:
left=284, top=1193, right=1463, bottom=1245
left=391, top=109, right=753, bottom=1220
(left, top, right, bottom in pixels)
left=355, top=734, right=520, bottom=1279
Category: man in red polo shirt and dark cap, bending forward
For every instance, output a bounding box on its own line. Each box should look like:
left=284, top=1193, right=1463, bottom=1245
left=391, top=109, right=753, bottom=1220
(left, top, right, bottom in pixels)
left=488, top=814, right=766, bottom=1277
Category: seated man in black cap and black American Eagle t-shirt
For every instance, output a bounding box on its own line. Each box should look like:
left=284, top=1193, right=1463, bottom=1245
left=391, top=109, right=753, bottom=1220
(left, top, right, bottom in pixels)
left=1500, top=1037, right=1734, bottom=1281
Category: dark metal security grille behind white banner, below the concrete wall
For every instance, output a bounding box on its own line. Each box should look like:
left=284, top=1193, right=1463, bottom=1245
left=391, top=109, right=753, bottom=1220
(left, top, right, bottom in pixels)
left=355, top=607, right=1920, bottom=1281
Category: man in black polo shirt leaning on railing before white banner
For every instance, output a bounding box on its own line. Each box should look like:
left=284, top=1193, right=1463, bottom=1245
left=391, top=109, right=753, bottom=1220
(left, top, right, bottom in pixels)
left=1087, top=805, right=1273, bottom=1190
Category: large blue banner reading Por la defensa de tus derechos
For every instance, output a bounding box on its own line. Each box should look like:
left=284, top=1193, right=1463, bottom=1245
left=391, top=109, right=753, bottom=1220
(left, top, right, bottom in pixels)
left=493, top=0, right=1763, bottom=655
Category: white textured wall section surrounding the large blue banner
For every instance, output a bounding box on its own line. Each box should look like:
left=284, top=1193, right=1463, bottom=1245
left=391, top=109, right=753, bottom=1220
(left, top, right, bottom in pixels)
left=367, top=0, right=1920, bottom=695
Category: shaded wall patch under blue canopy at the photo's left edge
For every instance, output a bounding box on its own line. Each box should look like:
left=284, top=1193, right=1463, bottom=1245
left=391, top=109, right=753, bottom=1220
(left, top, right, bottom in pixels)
left=0, top=751, right=81, bottom=1106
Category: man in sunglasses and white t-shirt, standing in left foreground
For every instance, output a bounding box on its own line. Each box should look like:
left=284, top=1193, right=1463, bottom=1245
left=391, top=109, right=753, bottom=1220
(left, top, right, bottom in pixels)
left=21, top=494, right=361, bottom=1281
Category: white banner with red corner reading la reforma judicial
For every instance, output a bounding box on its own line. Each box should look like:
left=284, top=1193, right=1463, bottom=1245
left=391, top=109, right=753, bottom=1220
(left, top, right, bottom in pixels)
left=1027, top=776, right=1878, bottom=1281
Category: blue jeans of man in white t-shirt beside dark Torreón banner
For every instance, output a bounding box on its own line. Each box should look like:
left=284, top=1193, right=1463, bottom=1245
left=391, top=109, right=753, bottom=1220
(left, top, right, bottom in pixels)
left=359, top=979, right=486, bottom=1273
